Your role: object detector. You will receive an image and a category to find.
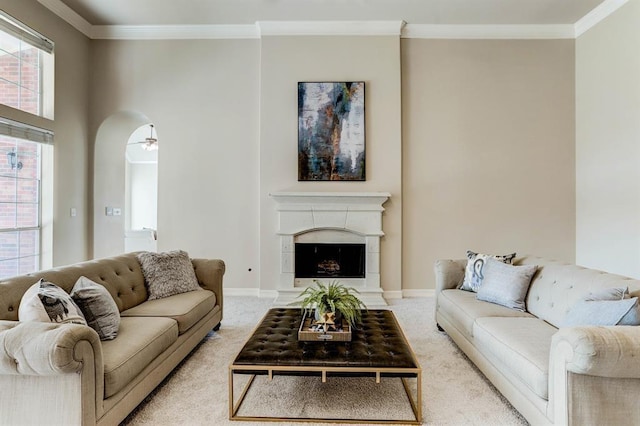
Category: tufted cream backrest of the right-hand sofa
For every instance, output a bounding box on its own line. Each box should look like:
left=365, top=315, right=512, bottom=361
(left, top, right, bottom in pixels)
left=514, top=256, right=640, bottom=327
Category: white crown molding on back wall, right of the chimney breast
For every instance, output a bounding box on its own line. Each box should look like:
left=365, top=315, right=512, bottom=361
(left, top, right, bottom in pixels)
left=402, top=24, right=574, bottom=39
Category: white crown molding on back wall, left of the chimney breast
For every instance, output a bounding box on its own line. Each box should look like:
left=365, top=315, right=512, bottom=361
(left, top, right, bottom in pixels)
left=91, top=25, right=260, bottom=40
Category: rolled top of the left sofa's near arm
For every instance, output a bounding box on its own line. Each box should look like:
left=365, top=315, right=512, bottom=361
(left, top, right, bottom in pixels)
left=0, top=321, right=102, bottom=376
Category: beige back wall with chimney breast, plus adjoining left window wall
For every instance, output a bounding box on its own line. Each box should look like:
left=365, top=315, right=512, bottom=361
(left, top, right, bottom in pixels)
left=10, top=0, right=593, bottom=292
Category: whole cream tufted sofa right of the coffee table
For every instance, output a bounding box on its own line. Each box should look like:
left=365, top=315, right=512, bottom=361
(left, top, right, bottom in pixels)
left=435, top=257, right=640, bottom=426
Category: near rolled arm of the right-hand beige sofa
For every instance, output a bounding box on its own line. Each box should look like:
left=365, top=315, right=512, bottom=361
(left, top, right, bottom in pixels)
left=547, top=326, right=640, bottom=425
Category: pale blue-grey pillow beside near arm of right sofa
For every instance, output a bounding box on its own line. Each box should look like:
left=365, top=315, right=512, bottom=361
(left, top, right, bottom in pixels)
left=561, top=287, right=640, bottom=327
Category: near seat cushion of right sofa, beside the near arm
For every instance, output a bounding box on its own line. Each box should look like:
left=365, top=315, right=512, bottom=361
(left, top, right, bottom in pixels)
left=473, top=317, right=558, bottom=400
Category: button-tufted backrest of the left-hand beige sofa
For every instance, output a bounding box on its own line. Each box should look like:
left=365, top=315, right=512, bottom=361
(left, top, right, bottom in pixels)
left=0, top=253, right=147, bottom=321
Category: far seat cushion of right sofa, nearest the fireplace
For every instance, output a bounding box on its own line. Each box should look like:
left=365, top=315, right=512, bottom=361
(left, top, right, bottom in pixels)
left=437, top=289, right=532, bottom=338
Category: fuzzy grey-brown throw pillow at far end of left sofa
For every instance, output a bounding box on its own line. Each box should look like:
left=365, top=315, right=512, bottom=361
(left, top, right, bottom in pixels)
left=138, top=250, right=200, bottom=300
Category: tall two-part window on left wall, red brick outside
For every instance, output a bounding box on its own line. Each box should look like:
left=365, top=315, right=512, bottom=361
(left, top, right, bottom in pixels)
left=0, top=10, right=54, bottom=278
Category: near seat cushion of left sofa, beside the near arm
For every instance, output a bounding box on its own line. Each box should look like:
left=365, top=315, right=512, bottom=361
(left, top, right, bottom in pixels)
left=102, top=317, right=178, bottom=398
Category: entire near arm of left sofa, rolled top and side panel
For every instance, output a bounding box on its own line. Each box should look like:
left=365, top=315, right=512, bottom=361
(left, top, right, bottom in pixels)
left=0, top=320, right=104, bottom=425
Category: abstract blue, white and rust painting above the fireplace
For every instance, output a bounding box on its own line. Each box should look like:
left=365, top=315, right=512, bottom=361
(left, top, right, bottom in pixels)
left=298, top=82, right=365, bottom=181
